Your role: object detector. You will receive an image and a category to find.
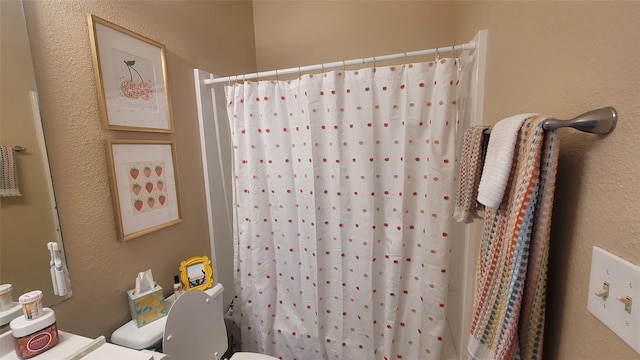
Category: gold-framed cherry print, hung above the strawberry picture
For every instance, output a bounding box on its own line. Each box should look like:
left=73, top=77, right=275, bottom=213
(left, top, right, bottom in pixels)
left=88, top=14, right=173, bottom=133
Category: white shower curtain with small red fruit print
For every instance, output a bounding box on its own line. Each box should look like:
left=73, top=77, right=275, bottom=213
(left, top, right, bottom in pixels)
left=226, top=59, right=464, bottom=360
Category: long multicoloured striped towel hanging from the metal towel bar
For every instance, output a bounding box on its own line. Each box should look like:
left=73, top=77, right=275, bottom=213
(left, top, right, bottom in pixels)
left=467, top=117, right=559, bottom=360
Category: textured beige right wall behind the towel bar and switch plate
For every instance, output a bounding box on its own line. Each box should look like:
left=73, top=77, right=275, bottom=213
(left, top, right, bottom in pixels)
left=456, top=1, right=640, bottom=359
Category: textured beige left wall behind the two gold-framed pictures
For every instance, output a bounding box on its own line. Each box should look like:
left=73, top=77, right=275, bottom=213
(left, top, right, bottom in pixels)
left=25, top=1, right=255, bottom=336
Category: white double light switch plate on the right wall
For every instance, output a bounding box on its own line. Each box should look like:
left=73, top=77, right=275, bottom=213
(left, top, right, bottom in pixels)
left=587, top=246, right=640, bottom=353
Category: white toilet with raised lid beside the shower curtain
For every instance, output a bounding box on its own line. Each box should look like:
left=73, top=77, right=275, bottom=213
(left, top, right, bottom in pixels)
left=111, top=284, right=276, bottom=360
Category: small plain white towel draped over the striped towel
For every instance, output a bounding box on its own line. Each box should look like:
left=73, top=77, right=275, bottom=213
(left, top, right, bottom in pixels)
left=478, top=114, right=538, bottom=209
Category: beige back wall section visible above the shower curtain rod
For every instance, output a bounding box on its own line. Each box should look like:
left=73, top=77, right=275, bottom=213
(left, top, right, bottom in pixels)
left=253, top=0, right=455, bottom=71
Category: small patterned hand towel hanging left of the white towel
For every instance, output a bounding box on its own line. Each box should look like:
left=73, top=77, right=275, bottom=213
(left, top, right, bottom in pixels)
left=453, top=125, right=489, bottom=224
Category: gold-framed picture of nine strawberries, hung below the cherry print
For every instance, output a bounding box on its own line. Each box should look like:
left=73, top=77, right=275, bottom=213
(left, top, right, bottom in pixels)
left=106, top=140, right=182, bottom=241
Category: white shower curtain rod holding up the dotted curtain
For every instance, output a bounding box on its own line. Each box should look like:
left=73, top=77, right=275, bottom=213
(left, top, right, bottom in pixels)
left=204, top=41, right=476, bottom=85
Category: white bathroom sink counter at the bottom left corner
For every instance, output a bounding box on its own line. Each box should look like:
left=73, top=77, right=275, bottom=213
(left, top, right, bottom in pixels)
left=0, top=331, right=153, bottom=360
